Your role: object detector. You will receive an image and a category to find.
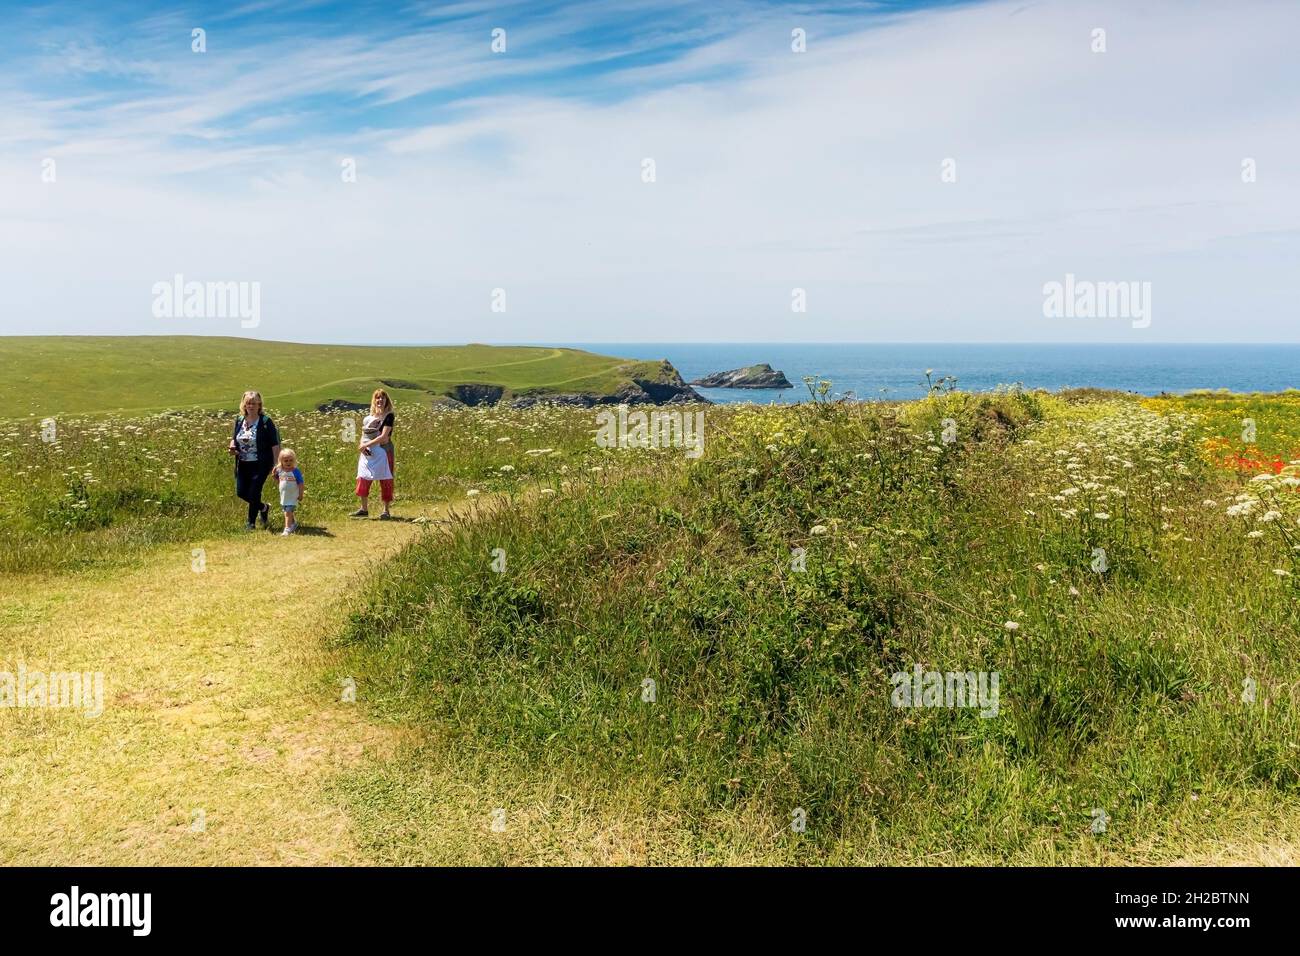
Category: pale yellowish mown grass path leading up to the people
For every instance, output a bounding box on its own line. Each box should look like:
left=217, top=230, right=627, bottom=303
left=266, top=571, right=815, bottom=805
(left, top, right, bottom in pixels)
left=0, top=503, right=441, bottom=865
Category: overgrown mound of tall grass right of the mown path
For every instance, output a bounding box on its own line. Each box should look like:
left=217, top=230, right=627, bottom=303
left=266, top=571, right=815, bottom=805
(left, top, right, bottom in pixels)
left=343, top=390, right=1300, bottom=860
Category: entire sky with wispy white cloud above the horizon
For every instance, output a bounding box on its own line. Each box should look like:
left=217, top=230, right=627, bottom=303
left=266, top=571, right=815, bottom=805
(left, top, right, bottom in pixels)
left=0, top=0, right=1300, bottom=347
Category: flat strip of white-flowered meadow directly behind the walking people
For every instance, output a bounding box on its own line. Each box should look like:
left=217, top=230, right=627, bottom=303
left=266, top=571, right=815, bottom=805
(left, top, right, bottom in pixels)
left=0, top=402, right=598, bottom=572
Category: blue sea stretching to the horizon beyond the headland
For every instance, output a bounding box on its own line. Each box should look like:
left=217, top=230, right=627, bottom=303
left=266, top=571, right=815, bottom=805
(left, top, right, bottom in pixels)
left=546, top=342, right=1300, bottom=405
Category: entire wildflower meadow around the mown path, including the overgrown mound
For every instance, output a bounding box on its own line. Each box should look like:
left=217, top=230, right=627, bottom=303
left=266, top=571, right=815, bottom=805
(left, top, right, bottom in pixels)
left=0, top=386, right=1300, bottom=864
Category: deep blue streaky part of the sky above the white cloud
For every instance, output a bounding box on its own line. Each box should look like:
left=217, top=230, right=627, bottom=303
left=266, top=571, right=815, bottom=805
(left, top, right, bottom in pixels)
left=0, top=0, right=953, bottom=162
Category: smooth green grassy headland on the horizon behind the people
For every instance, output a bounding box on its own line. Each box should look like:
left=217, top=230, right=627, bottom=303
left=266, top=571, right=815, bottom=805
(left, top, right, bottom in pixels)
left=0, top=336, right=658, bottom=419
